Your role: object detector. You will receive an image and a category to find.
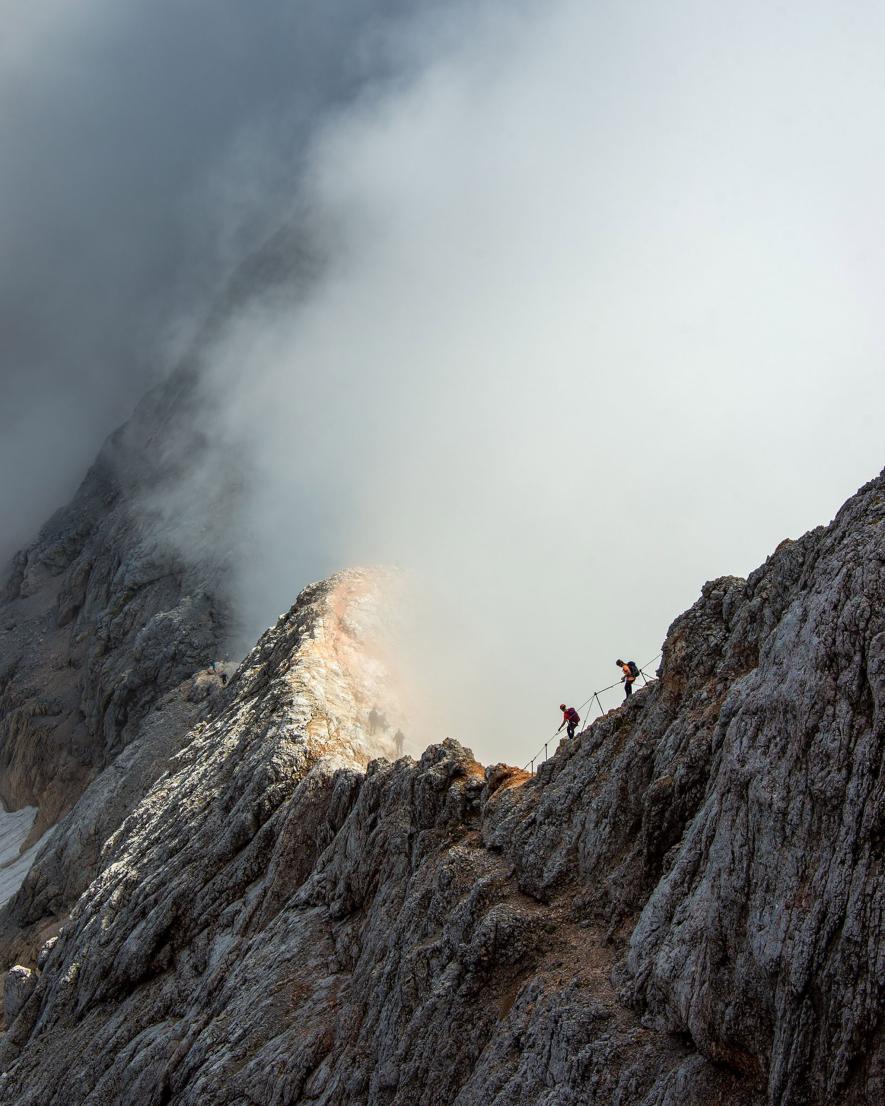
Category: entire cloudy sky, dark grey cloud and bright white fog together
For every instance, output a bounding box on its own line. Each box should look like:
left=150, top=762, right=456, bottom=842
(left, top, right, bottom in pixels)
left=0, top=0, right=885, bottom=762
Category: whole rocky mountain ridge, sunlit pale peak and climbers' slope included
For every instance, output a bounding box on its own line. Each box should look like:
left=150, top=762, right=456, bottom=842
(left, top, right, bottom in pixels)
left=0, top=460, right=885, bottom=1106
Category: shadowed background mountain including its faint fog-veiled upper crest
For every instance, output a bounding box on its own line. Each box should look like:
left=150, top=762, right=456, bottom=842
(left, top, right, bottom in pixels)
left=0, top=213, right=321, bottom=906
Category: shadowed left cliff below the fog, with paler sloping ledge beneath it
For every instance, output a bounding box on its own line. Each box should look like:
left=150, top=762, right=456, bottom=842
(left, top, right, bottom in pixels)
left=0, top=366, right=230, bottom=954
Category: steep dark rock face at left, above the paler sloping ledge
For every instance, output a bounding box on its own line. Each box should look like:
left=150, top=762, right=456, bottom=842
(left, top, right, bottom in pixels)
left=0, top=369, right=227, bottom=832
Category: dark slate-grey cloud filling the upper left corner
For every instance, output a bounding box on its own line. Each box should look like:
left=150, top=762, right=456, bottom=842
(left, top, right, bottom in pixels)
left=0, top=0, right=442, bottom=559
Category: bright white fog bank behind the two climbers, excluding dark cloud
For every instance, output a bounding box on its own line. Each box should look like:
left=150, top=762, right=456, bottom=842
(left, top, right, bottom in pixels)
left=4, top=0, right=885, bottom=762
